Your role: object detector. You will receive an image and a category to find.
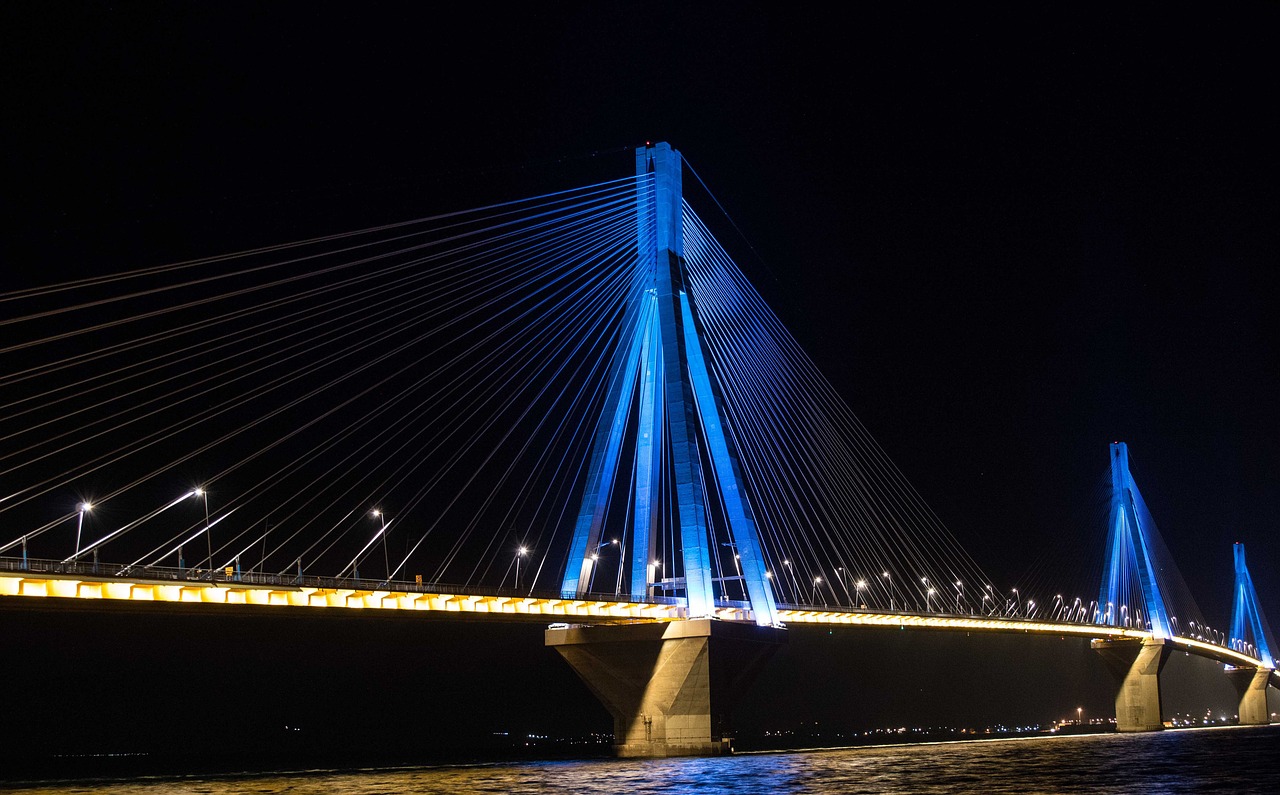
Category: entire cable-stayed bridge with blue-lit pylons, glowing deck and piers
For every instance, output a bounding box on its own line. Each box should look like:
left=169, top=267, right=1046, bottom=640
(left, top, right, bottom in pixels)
left=0, top=145, right=1276, bottom=755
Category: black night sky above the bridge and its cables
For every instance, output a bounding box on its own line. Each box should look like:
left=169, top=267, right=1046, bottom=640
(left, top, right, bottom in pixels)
left=0, top=3, right=1280, bottom=768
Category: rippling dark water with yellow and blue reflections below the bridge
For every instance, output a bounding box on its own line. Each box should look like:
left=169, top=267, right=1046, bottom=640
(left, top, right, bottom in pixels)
left=12, top=727, right=1280, bottom=795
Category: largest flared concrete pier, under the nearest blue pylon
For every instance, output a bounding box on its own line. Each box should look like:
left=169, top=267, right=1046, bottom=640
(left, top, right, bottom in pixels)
left=545, top=618, right=786, bottom=757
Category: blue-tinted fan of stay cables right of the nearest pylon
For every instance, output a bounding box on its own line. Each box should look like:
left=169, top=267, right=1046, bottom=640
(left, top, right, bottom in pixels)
left=684, top=202, right=989, bottom=604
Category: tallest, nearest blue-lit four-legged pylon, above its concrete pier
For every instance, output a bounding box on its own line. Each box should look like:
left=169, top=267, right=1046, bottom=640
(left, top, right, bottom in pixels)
left=562, top=143, right=777, bottom=625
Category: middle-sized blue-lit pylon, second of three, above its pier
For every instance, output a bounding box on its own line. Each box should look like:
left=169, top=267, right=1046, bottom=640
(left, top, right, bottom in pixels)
left=1098, top=442, right=1172, bottom=638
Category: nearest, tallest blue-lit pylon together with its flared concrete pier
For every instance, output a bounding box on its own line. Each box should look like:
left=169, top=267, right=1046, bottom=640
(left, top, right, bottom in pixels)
left=545, top=143, right=786, bottom=757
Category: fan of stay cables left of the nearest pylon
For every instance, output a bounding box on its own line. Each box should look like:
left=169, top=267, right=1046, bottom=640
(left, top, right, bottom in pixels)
left=0, top=177, right=655, bottom=586
